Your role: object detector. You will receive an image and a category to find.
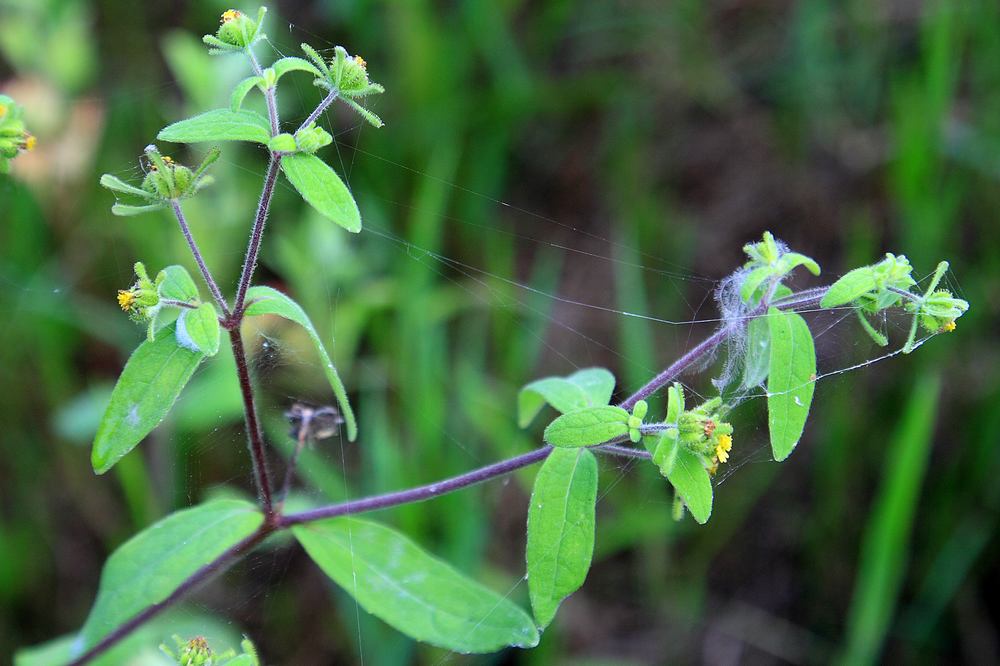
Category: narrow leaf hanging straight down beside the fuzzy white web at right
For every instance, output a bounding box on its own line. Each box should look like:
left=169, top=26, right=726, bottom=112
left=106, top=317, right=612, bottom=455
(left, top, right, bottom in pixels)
left=767, top=308, right=816, bottom=462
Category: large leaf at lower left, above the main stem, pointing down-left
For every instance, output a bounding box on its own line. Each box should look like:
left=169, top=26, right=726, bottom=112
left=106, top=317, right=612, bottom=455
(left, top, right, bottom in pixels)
left=79, top=500, right=264, bottom=653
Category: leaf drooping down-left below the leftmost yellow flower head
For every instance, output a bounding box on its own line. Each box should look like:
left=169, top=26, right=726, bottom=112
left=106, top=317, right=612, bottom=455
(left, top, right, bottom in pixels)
left=90, top=322, right=205, bottom=474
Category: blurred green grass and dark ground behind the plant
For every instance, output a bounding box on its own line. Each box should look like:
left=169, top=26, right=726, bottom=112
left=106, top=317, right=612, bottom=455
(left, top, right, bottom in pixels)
left=0, top=0, right=1000, bottom=664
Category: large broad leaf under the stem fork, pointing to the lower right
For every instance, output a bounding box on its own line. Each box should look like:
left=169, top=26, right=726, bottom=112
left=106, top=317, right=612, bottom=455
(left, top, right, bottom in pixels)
left=292, top=518, right=538, bottom=653
